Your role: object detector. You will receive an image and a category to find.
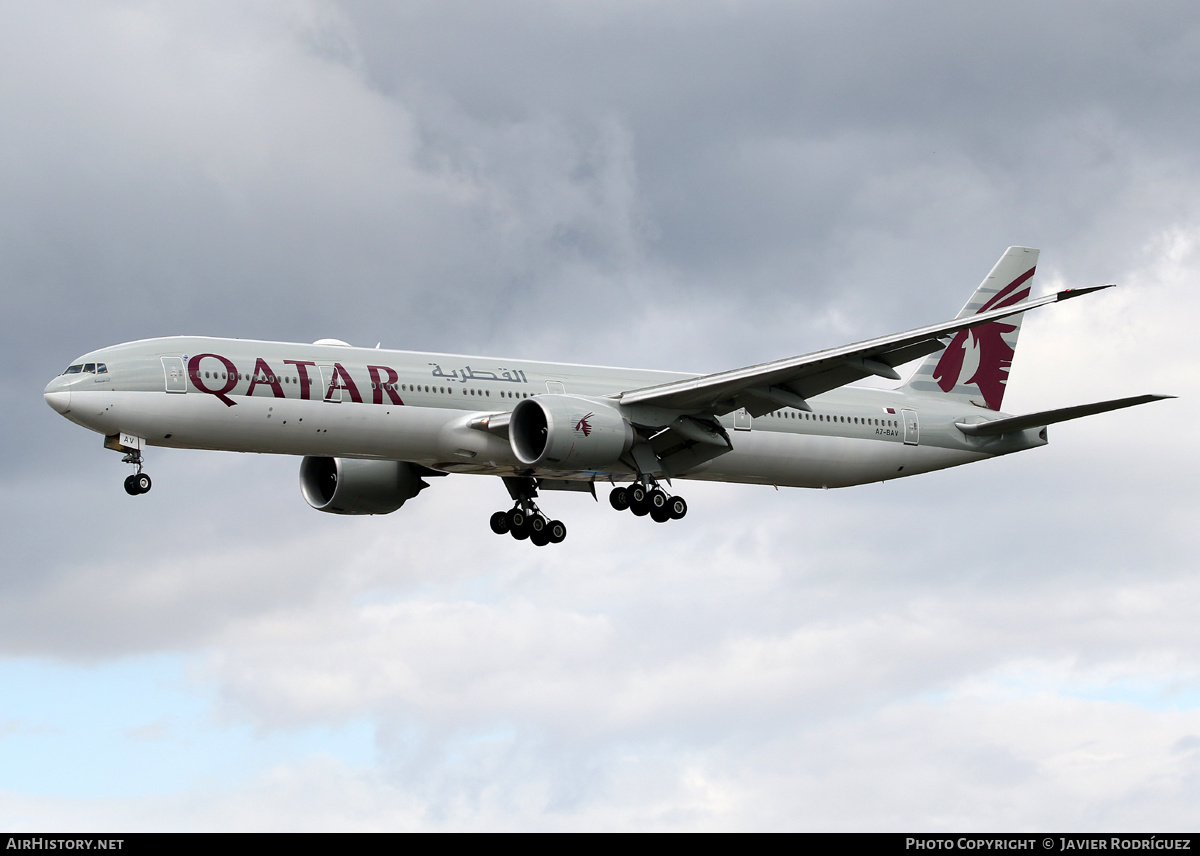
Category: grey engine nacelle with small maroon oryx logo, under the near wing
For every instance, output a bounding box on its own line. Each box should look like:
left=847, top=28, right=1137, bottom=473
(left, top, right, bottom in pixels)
left=509, top=395, right=634, bottom=469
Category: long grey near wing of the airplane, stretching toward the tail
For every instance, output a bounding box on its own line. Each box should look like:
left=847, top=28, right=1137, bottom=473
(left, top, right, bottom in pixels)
left=613, top=286, right=1112, bottom=417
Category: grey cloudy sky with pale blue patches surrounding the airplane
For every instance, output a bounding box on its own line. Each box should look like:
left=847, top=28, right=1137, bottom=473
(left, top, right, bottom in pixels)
left=0, top=0, right=1200, bottom=831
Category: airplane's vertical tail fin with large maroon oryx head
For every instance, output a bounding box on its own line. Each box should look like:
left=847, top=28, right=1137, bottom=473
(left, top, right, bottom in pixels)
left=904, top=246, right=1038, bottom=411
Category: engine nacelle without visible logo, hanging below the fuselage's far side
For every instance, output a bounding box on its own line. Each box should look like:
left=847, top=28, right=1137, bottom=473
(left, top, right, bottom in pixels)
left=300, top=457, right=430, bottom=514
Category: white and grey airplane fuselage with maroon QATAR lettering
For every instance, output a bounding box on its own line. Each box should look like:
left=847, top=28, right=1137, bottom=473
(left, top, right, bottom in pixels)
left=46, top=337, right=1045, bottom=487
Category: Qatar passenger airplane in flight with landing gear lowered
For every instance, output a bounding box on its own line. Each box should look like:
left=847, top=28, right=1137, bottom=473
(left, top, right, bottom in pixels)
left=44, top=247, right=1175, bottom=546
